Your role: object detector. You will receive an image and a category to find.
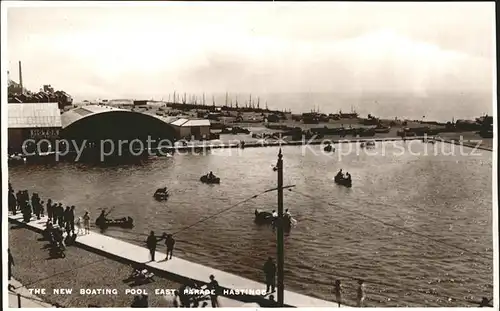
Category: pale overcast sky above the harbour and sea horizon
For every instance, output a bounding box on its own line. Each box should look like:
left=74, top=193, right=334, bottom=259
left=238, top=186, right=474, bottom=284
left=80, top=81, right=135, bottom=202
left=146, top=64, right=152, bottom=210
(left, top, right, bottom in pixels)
left=7, top=2, right=495, bottom=98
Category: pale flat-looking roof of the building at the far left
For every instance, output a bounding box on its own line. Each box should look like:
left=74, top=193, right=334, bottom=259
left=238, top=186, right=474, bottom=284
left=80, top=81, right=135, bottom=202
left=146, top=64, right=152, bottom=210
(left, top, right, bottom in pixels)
left=7, top=103, right=62, bottom=128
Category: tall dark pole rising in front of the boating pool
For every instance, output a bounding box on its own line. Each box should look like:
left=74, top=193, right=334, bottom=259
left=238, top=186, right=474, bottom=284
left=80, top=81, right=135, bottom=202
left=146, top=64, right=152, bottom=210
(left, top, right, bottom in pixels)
left=277, top=148, right=285, bottom=306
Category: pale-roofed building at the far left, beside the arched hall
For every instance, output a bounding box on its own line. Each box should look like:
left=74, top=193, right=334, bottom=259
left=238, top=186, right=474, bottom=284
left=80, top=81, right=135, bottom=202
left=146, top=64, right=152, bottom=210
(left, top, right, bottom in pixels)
left=7, top=103, right=62, bottom=154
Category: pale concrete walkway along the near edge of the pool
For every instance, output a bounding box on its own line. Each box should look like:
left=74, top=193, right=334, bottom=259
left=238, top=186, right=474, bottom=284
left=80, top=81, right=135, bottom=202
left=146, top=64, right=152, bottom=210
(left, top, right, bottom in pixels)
left=9, top=213, right=346, bottom=308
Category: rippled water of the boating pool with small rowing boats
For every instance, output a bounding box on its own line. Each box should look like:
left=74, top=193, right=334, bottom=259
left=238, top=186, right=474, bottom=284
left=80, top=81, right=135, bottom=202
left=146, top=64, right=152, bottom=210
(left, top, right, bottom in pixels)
left=9, top=142, right=493, bottom=306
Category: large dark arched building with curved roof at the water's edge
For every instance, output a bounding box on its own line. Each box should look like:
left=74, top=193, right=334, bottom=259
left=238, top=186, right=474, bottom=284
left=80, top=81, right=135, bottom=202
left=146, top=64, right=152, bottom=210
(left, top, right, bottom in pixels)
left=61, top=105, right=175, bottom=155
